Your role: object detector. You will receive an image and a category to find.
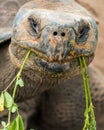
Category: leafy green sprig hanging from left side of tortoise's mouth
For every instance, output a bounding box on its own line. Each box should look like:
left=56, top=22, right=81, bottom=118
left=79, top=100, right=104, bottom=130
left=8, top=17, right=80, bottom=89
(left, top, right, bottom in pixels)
left=0, top=50, right=30, bottom=130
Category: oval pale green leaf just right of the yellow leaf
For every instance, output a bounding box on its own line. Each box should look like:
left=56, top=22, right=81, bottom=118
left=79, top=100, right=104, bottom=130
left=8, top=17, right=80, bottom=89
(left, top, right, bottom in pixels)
left=4, top=91, right=13, bottom=108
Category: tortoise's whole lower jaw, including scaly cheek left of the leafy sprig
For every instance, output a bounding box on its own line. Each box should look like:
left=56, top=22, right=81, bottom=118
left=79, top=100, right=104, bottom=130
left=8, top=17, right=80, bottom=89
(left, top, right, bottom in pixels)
left=10, top=43, right=94, bottom=74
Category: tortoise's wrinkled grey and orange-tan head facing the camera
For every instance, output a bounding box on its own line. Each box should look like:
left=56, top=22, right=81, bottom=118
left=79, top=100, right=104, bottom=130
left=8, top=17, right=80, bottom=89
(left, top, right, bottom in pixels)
left=9, top=2, right=98, bottom=79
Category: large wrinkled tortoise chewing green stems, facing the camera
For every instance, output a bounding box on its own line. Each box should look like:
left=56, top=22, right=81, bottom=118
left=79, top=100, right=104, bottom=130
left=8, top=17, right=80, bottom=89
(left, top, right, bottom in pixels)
left=0, top=0, right=104, bottom=130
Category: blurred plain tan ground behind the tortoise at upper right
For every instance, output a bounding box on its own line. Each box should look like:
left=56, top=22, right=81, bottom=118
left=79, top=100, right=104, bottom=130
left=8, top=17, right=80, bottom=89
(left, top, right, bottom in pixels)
left=78, top=0, right=104, bottom=74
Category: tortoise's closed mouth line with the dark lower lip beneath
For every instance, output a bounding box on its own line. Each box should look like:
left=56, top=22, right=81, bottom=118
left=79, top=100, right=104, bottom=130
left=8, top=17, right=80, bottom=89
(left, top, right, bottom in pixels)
left=17, top=43, right=94, bottom=74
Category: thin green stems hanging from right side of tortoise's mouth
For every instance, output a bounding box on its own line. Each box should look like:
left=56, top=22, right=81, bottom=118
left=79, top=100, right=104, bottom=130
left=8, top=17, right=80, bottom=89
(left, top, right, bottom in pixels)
left=79, top=56, right=96, bottom=130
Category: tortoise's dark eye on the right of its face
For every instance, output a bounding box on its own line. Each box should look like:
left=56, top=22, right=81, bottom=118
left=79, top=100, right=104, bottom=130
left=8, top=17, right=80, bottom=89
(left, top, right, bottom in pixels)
left=76, top=26, right=90, bottom=45
